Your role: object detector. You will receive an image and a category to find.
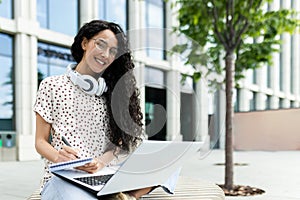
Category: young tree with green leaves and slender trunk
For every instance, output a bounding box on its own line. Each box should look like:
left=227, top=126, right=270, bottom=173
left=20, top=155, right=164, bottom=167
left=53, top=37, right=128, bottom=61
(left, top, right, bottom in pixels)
left=172, top=0, right=299, bottom=194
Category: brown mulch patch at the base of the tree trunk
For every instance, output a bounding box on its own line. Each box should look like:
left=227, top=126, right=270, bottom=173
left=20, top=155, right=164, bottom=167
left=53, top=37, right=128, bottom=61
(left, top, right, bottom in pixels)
left=218, top=184, right=265, bottom=196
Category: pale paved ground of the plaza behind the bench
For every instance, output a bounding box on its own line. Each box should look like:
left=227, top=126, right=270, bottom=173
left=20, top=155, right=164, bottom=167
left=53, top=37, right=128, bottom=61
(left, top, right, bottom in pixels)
left=0, top=150, right=300, bottom=200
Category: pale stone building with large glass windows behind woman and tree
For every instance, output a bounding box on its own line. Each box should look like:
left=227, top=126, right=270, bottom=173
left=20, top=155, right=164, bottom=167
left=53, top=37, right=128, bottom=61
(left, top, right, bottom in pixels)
left=0, top=0, right=300, bottom=160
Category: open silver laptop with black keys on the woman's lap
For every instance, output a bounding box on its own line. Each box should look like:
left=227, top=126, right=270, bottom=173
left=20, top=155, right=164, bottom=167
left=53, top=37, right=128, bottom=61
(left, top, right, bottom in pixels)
left=52, top=140, right=203, bottom=196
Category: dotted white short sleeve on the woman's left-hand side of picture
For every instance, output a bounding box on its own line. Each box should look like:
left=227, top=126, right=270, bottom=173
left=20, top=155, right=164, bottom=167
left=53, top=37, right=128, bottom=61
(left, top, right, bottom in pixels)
left=33, top=78, right=53, bottom=124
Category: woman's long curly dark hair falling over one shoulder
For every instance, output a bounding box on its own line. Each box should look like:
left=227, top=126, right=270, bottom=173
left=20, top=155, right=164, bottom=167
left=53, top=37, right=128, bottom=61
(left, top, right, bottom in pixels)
left=71, top=20, right=143, bottom=152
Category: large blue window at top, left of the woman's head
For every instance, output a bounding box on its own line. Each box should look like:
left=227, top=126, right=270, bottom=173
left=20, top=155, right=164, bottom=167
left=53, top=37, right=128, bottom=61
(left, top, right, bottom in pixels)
left=37, top=0, right=78, bottom=35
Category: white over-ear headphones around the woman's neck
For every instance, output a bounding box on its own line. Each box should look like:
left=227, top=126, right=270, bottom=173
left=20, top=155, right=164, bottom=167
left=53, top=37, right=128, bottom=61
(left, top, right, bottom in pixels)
left=66, top=63, right=107, bottom=96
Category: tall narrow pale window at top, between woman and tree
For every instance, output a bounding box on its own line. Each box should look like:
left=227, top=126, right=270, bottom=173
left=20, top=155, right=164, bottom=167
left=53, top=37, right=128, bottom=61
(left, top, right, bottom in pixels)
left=145, top=0, right=166, bottom=59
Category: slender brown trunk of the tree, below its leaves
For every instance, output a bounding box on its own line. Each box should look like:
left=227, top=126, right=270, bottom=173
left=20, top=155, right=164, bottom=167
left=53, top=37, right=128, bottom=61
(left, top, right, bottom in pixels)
left=225, top=53, right=234, bottom=189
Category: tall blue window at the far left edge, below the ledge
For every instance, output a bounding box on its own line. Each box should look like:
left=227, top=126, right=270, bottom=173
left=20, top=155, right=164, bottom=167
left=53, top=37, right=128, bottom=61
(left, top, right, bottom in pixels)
left=0, top=33, right=15, bottom=131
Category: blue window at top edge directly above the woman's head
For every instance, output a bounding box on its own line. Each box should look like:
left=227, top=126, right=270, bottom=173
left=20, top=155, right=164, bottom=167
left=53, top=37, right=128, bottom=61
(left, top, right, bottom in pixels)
left=99, top=0, right=127, bottom=31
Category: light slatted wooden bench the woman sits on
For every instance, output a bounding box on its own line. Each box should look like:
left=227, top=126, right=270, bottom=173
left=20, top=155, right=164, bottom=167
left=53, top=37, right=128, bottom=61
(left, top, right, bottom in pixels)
left=27, top=177, right=225, bottom=200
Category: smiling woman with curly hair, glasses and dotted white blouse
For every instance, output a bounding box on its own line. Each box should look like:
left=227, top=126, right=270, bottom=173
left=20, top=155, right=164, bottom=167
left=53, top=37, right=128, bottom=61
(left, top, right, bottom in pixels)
left=34, top=20, right=151, bottom=200
